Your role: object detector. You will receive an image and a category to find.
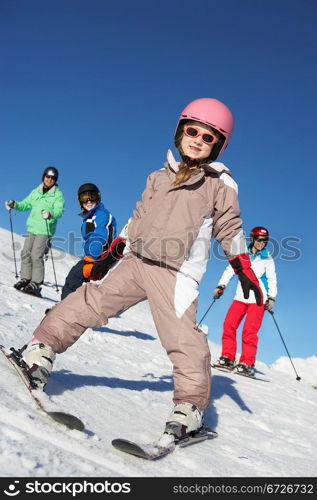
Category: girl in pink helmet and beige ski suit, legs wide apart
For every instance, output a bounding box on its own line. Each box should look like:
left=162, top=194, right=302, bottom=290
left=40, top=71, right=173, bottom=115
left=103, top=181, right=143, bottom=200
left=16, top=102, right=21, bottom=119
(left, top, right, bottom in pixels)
left=21, top=98, right=263, bottom=439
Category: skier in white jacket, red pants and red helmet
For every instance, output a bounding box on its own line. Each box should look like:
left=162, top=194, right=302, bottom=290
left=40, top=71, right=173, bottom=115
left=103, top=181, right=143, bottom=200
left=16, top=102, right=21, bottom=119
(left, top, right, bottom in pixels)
left=214, top=226, right=277, bottom=376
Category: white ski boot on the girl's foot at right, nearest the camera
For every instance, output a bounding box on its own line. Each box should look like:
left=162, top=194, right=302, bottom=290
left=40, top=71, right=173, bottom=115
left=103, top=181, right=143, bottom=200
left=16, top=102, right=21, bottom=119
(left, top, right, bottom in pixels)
left=158, top=403, right=203, bottom=447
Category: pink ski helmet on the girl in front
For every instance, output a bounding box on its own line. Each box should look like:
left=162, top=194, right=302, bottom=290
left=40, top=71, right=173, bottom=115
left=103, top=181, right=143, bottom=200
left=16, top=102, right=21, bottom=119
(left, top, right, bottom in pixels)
left=174, top=97, right=233, bottom=161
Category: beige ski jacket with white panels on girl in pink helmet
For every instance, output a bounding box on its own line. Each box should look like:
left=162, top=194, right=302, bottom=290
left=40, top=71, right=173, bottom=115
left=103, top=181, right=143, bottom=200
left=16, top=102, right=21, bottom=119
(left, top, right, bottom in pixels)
left=127, top=151, right=247, bottom=283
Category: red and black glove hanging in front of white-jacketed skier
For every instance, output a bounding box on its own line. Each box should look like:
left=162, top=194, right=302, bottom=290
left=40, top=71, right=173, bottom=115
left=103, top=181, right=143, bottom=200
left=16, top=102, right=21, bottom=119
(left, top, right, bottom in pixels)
left=229, top=253, right=263, bottom=306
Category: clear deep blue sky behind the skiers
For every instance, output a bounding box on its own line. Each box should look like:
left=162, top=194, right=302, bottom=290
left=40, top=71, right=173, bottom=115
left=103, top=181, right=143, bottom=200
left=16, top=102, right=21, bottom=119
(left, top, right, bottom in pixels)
left=0, top=0, right=317, bottom=363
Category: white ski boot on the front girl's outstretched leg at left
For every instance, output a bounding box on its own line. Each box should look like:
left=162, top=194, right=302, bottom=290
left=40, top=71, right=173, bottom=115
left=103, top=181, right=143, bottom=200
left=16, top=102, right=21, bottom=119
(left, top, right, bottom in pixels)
left=18, top=339, right=56, bottom=389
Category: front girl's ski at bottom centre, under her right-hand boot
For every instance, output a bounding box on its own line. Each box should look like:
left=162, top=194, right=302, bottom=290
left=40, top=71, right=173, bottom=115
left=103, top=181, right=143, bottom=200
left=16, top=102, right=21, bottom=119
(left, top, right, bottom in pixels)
left=111, top=427, right=218, bottom=460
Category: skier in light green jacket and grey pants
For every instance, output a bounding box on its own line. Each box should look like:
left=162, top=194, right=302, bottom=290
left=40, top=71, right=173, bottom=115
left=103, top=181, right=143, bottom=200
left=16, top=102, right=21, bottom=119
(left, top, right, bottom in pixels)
left=5, top=167, right=65, bottom=297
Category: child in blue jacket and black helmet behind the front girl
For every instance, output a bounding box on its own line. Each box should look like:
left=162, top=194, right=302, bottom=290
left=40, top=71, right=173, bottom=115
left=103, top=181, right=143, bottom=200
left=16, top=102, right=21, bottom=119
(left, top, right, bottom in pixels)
left=61, top=183, right=125, bottom=300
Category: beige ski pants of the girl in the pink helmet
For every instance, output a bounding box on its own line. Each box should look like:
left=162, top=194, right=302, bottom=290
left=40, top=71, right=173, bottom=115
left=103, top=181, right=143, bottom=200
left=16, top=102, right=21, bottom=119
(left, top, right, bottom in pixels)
left=34, top=253, right=211, bottom=410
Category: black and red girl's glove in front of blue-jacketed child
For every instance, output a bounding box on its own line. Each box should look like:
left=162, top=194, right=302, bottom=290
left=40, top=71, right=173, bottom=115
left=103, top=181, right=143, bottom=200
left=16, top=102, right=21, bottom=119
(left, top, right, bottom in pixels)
left=83, top=236, right=126, bottom=281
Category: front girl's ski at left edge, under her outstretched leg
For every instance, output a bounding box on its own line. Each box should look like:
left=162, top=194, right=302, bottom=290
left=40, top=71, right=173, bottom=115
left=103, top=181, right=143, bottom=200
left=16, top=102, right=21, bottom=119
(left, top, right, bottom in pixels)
left=0, top=345, right=85, bottom=431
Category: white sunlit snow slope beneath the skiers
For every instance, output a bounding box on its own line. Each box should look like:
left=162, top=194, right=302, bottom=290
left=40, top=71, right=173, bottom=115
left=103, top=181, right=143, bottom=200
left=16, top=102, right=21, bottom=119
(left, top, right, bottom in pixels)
left=0, top=229, right=317, bottom=478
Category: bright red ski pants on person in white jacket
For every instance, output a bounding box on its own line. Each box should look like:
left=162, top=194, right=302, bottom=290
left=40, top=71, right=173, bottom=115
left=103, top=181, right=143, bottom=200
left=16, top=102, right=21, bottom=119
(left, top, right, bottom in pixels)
left=222, top=300, right=264, bottom=365
